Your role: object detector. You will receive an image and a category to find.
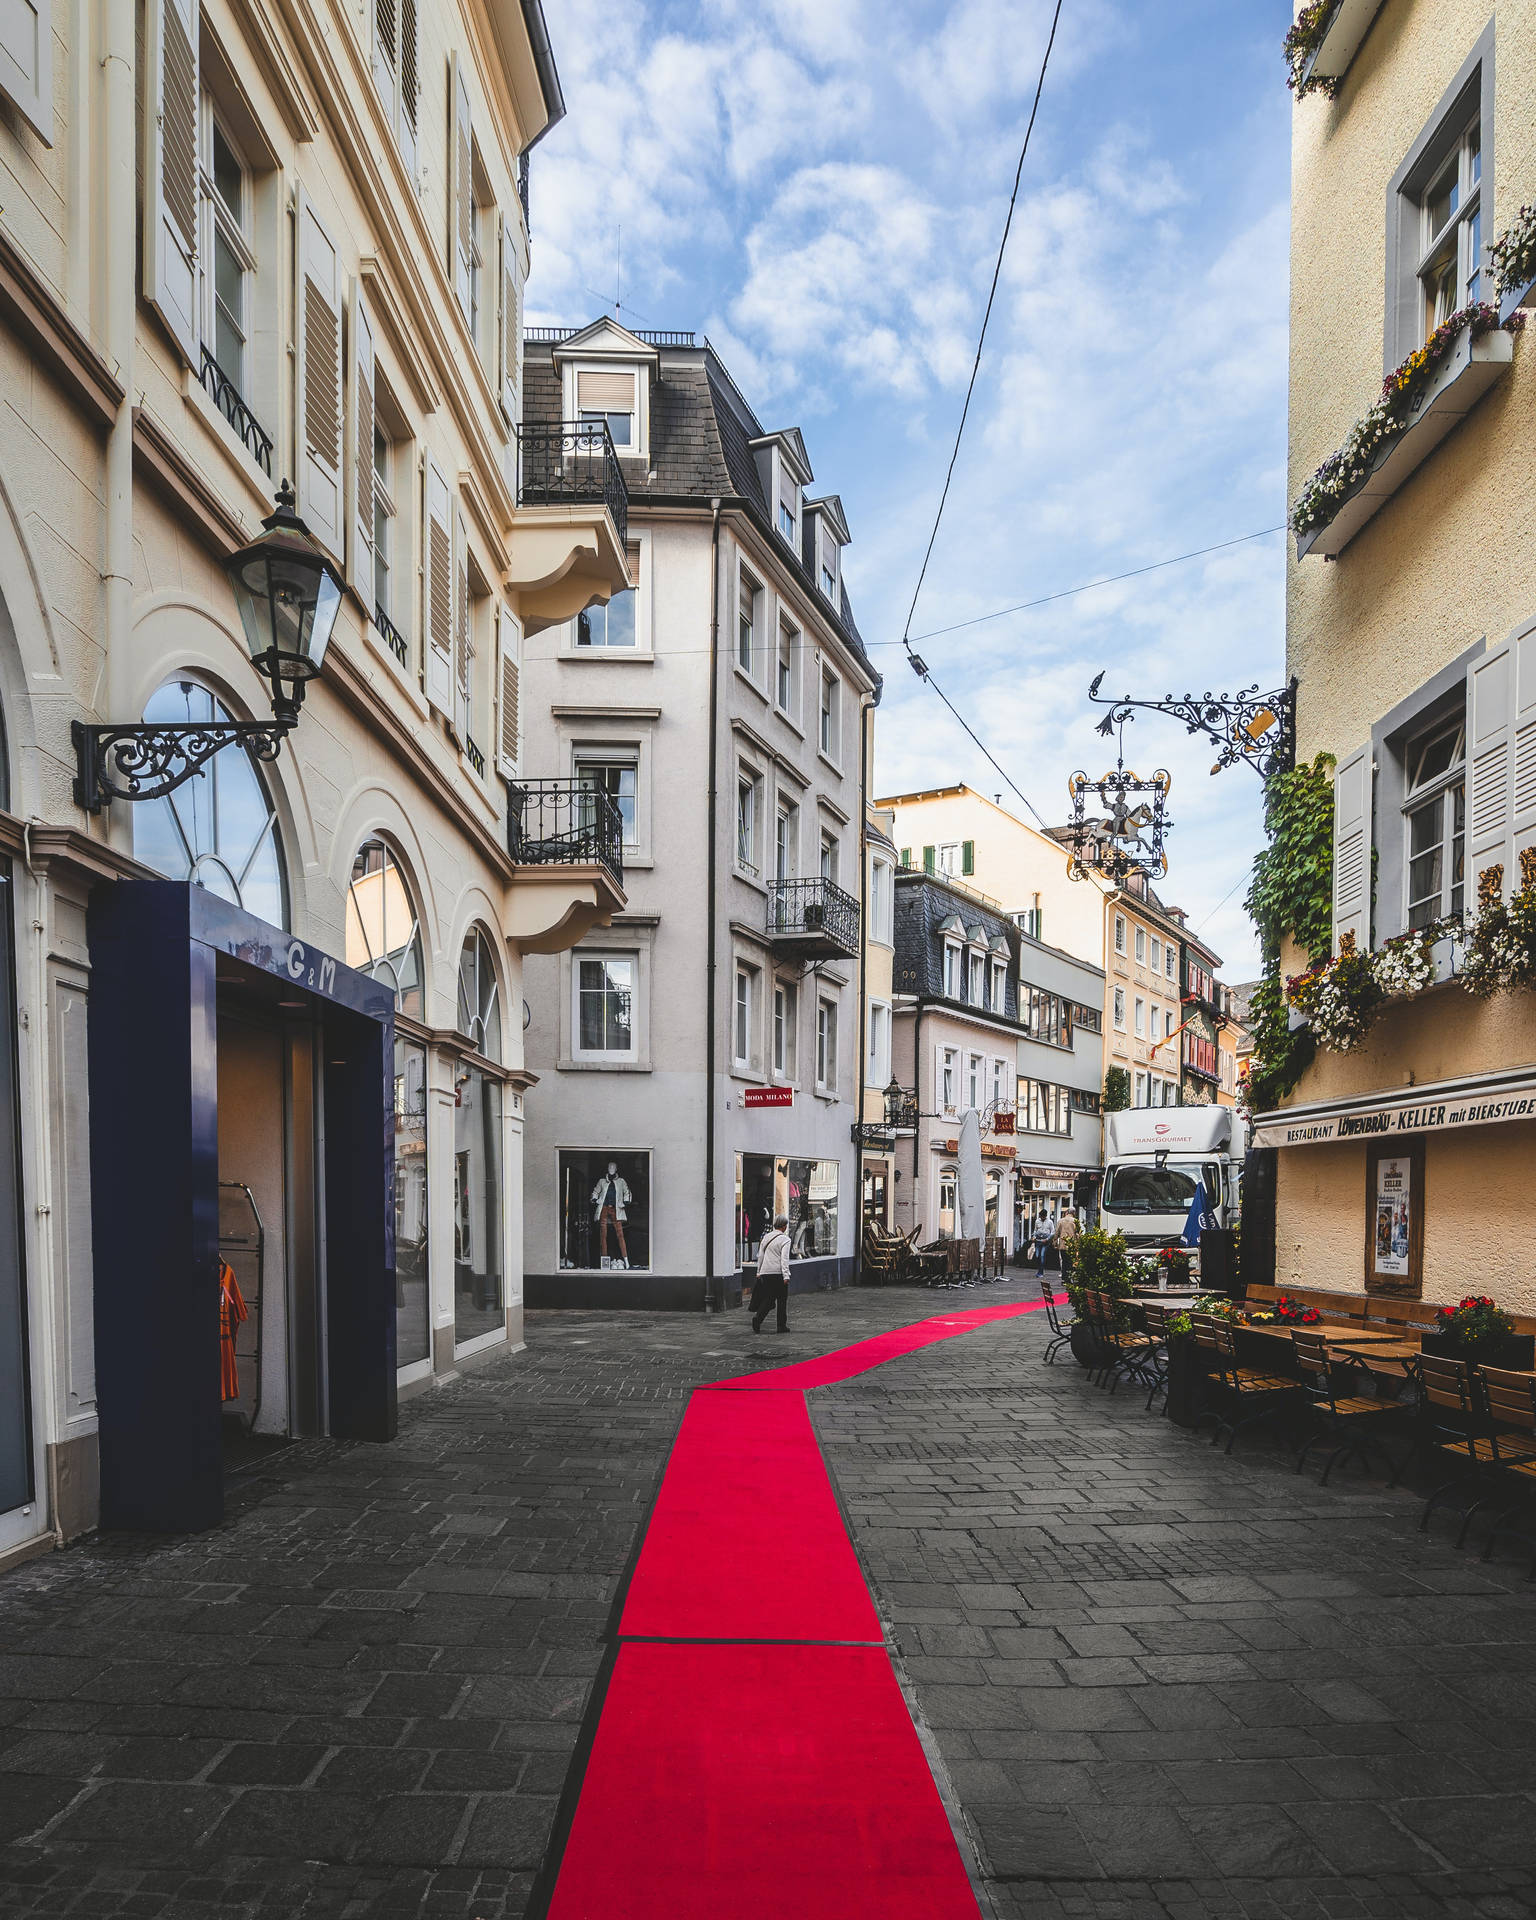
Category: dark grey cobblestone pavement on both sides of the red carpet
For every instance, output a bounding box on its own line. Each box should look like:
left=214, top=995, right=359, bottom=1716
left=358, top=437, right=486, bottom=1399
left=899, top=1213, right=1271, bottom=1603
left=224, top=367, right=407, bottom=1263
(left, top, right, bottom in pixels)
left=0, top=1283, right=1536, bottom=1920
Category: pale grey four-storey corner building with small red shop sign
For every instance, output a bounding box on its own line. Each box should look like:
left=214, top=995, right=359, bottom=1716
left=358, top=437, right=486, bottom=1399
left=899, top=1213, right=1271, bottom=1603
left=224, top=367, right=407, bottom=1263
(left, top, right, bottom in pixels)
left=524, top=321, right=879, bottom=1311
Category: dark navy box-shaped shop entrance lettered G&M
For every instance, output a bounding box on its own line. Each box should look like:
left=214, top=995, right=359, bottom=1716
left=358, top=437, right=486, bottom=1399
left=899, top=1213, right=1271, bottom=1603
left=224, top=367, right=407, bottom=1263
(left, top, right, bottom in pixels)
left=90, top=881, right=396, bottom=1532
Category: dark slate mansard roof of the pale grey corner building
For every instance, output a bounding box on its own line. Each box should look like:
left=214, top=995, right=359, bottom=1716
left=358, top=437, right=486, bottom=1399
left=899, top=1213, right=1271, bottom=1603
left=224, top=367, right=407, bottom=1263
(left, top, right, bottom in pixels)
left=522, top=336, right=881, bottom=693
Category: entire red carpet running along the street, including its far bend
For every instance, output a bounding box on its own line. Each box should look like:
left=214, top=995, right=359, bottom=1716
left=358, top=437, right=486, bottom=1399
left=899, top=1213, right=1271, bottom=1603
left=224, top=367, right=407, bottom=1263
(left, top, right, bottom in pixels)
left=549, top=1300, right=1043, bottom=1920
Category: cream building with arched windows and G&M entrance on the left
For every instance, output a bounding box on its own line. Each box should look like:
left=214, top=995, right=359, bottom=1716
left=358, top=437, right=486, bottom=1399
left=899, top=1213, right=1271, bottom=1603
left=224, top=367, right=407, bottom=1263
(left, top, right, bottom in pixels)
left=0, top=0, right=628, bottom=1559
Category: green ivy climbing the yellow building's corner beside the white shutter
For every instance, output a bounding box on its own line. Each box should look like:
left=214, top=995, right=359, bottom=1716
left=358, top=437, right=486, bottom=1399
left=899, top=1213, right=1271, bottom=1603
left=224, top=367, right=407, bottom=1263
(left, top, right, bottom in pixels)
left=1244, top=753, right=1334, bottom=1114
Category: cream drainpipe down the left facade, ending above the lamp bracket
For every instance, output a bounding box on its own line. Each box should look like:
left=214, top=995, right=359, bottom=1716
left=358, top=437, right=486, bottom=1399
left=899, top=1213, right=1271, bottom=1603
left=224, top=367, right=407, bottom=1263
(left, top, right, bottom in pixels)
left=94, top=0, right=138, bottom=764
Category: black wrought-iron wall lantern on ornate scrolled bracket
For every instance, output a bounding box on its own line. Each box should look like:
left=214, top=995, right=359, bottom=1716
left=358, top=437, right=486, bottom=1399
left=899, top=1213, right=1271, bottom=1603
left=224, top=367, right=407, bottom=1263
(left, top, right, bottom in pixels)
left=71, top=480, right=344, bottom=814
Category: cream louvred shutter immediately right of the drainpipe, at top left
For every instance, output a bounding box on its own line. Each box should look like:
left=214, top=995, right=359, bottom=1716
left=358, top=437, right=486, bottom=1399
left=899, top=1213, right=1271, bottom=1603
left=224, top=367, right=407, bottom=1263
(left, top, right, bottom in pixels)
left=143, top=0, right=202, bottom=369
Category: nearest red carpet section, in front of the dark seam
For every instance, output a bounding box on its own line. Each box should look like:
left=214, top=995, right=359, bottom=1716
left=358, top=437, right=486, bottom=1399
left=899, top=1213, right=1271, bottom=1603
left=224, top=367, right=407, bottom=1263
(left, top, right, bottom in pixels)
left=549, top=1645, right=977, bottom=1920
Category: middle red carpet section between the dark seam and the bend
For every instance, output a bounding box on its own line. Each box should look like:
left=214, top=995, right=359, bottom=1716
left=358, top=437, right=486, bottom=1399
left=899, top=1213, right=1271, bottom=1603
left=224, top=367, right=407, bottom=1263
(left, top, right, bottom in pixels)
left=618, top=1392, right=881, bottom=1645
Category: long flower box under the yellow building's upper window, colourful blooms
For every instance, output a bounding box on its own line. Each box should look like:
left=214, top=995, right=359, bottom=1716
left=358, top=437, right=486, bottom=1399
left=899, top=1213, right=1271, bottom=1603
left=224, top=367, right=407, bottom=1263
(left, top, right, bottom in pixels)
left=1290, top=301, right=1524, bottom=561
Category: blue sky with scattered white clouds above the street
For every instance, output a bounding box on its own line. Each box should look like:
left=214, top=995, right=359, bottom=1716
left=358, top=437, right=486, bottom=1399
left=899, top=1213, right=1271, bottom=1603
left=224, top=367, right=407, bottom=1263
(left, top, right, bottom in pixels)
left=528, top=0, right=1308, bottom=979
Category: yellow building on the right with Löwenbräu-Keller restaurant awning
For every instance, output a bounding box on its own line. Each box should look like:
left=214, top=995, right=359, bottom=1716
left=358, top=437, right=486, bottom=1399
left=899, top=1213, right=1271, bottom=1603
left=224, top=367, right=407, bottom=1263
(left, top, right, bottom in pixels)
left=1256, top=0, right=1536, bottom=1313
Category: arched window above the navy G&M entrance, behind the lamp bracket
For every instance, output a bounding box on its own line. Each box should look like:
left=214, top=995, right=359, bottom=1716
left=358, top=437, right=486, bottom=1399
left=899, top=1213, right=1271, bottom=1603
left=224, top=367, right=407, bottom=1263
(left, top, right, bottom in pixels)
left=132, top=680, right=288, bottom=927
